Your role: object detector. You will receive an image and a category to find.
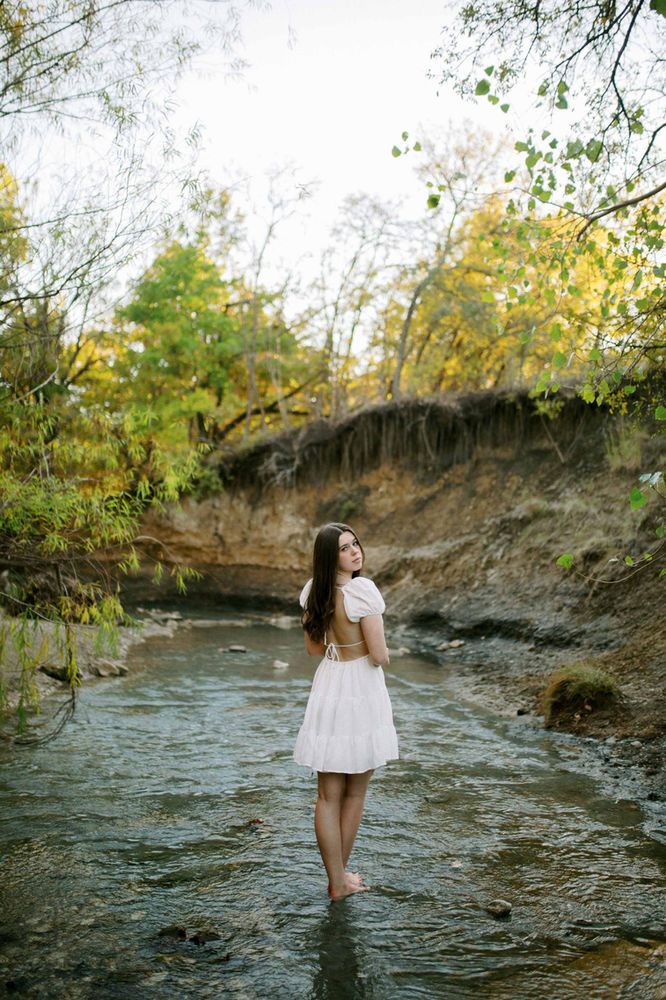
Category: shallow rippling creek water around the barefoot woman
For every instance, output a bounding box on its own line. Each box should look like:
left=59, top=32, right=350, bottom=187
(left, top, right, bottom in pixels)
left=0, top=624, right=666, bottom=1000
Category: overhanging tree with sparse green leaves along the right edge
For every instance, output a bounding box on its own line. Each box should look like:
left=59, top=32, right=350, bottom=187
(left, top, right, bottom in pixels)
left=426, top=0, right=666, bottom=575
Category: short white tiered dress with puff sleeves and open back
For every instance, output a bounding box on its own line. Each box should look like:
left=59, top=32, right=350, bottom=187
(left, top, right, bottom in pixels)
left=294, top=576, right=399, bottom=774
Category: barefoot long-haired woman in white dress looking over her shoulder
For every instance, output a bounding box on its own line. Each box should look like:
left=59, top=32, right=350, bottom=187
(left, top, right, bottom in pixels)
left=294, top=524, right=398, bottom=900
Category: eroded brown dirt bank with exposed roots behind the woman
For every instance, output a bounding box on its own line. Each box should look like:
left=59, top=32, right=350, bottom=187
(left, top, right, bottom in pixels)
left=128, top=394, right=666, bottom=774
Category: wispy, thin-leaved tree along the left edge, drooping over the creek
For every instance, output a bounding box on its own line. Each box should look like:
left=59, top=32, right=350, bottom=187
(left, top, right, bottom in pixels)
left=0, top=0, right=256, bottom=728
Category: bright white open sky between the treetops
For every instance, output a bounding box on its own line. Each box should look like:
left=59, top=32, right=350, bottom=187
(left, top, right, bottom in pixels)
left=170, top=0, right=524, bottom=288
